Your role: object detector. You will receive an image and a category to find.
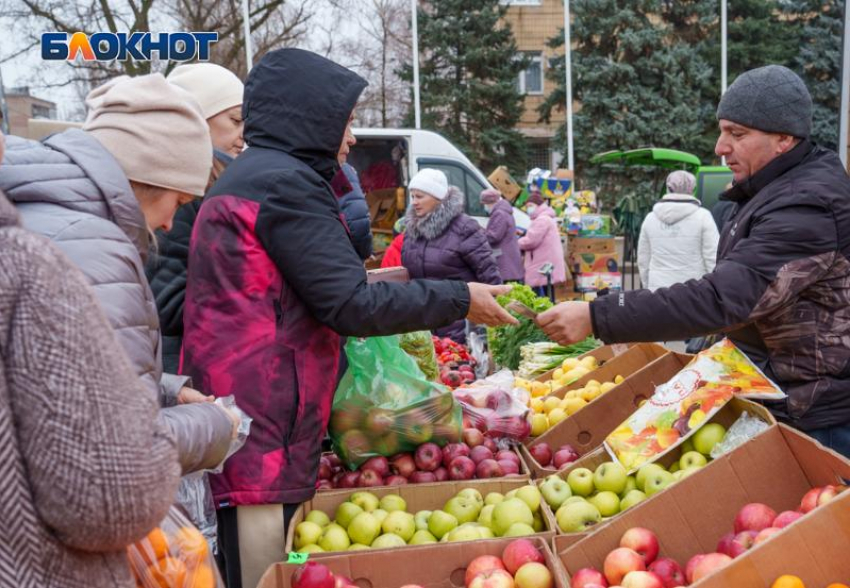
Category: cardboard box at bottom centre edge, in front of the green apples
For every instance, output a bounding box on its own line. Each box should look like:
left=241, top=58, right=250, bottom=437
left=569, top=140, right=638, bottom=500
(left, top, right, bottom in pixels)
left=257, top=537, right=569, bottom=588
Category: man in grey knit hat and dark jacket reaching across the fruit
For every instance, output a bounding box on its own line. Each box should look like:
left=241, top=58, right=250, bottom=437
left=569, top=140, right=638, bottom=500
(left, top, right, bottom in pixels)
left=539, top=66, right=850, bottom=456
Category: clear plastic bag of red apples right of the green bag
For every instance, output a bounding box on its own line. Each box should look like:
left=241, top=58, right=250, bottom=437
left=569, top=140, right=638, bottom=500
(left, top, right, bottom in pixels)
left=454, top=370, right=531, bottom=441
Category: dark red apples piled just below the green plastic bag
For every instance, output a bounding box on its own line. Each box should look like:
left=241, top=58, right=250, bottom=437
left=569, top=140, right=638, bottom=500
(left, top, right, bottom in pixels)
left=316, top=438, right=522, bottom=490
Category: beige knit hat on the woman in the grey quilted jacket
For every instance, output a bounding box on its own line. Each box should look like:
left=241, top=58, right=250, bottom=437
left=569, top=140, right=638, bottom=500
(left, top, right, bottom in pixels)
left=83, top=74, right=212, bottom=196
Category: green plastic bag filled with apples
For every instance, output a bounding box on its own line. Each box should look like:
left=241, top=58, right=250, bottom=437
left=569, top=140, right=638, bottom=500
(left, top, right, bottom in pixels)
left=329, top=336, right=463, bottom=469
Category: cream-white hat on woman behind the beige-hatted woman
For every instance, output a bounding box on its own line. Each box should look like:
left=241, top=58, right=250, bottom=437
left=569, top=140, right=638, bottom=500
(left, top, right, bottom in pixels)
left=167, top=63, right=245, bottom=119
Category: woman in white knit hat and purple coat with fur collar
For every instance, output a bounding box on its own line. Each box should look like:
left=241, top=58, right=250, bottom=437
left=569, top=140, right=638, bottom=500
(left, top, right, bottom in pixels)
left=401, top=169, right=502, bottom=343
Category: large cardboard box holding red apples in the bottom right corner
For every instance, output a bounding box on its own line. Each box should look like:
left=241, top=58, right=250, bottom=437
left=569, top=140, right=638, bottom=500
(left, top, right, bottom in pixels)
left=559, top=425, right=850, bottom=588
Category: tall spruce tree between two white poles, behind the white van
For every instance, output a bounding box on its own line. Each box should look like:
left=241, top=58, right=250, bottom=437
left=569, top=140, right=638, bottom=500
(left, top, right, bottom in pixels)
left=401, top=0, right=527, bottom=173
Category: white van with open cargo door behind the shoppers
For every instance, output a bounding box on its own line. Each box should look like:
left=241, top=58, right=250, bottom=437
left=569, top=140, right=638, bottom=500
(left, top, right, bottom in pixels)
left=348, top=129, right=531, bottom=231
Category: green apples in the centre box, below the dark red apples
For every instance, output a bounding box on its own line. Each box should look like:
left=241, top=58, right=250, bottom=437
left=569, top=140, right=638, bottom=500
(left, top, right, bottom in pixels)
left=295, top=485, right=545, bottom=553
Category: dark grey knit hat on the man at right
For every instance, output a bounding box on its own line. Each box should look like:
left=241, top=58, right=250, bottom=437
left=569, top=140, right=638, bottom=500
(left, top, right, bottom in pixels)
left=717, top=65, right=812, bottom=139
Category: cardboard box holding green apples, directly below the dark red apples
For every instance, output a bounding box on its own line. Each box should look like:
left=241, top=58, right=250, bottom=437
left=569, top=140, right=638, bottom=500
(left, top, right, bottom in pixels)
left=284, top=478, right=556, bottom=558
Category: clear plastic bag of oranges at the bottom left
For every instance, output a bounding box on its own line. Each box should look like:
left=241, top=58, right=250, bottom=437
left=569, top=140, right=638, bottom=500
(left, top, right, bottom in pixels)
left=127, top=506, right=224, bottom=588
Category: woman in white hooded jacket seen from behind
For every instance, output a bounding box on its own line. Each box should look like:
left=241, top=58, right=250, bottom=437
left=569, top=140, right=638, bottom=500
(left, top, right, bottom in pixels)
left=638, top=171, right=720, bottom=290
